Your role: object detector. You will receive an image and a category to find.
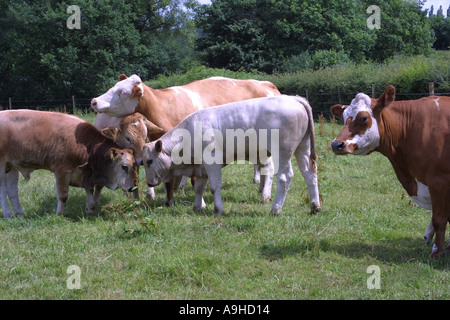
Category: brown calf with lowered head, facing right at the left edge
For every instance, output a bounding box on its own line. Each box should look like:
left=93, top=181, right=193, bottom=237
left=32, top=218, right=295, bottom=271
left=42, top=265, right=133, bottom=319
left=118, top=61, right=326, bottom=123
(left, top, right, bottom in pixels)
left=0, top=110, right=137, bottom=218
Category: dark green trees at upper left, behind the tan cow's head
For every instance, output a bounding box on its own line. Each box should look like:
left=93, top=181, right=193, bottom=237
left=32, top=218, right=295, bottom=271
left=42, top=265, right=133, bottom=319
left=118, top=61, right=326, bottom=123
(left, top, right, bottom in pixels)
left=0, top=0, right=199, bottom=100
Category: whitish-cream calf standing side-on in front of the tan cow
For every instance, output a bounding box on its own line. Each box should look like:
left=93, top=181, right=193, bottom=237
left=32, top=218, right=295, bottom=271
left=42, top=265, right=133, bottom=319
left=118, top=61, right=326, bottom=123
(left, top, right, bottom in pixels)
left=143, top=95, right=320, bottom=215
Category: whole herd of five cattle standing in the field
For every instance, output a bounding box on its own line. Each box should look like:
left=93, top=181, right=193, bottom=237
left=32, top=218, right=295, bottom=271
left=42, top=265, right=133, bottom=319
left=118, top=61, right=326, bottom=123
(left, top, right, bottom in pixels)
left=0, top=75, right=450, bottom=258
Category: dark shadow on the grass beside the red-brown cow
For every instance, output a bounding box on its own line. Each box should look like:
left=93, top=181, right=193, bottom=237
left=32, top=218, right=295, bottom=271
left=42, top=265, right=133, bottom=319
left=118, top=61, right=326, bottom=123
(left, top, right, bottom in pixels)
left=259, top=238, right=450, bottom=270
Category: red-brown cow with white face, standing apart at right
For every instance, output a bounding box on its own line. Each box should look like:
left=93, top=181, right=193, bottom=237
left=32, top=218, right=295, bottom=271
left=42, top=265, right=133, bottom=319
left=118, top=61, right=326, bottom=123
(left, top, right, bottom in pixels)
left=331, top=86, right=450, bottom=258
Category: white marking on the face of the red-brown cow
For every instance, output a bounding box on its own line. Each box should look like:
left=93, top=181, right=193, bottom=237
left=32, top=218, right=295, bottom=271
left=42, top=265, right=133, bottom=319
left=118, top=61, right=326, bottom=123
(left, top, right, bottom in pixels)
left=343, top=93, right=380, bottom=155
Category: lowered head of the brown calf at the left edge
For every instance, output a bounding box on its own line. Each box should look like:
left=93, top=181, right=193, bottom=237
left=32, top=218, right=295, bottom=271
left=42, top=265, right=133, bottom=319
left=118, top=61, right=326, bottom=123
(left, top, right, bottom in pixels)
left=105, top=148, right=138, bottom=191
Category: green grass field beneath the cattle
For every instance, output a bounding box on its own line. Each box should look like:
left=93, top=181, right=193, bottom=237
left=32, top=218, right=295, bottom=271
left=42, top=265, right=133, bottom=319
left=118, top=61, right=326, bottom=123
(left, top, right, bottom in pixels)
left=0, top=114, right=450, bottom=300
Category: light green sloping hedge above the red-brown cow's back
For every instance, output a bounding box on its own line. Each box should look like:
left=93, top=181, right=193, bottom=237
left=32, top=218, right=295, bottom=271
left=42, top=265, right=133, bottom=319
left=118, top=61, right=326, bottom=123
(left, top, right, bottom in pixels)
left=265, top=51, right=450, bottom=113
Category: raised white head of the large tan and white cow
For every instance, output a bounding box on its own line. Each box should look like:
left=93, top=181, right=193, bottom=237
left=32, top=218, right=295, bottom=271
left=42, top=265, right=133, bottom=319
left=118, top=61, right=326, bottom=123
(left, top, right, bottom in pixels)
left=91, top=74, right=144, bottom=117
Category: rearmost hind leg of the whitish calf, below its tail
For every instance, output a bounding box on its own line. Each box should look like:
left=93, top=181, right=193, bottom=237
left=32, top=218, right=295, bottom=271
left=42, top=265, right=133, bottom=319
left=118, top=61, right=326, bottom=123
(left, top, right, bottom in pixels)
left=294, top=144, right=320, bottom=214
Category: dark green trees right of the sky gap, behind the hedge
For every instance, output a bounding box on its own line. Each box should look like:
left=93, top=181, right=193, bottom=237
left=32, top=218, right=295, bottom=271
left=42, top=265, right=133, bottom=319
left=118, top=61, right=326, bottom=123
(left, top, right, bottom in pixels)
left=198, top=0, right=433, bottom=73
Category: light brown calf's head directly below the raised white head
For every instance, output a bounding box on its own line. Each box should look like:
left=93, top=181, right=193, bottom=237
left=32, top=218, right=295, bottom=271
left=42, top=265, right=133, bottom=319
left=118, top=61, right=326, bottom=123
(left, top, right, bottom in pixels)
left=102, top=113, right=164, bottom=163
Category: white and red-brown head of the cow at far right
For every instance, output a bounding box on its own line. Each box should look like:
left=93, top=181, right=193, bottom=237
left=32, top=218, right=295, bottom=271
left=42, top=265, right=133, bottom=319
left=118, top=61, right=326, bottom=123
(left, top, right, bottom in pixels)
left=331, top=86, right=395, bottom=155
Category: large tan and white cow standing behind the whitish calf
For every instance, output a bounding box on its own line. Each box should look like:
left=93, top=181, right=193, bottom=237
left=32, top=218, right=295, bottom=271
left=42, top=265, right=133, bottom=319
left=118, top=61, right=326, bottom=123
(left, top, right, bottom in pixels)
left=91, top=74, right=280, bottom=205
